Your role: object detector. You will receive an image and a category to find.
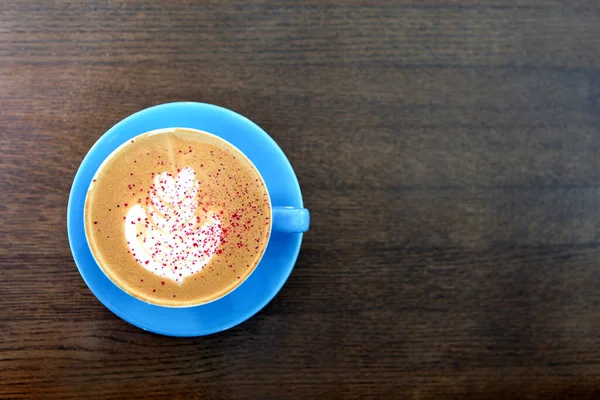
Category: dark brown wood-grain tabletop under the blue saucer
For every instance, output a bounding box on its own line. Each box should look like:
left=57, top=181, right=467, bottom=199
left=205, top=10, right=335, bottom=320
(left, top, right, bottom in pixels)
left=0, top=0, right=600, bottom=399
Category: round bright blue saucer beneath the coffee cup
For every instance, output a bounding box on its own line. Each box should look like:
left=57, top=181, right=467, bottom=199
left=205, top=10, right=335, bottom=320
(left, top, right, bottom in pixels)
left=67, top=103, right=303, bottom=336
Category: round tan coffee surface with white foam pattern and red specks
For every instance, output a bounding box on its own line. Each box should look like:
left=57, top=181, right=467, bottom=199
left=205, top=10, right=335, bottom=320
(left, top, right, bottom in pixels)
left=85, top=128, right=271, bottom=307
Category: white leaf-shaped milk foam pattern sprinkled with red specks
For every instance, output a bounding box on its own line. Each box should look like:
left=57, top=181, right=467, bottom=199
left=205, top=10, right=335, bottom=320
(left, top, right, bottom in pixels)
left=124, top=167, right=222, bottom=284
